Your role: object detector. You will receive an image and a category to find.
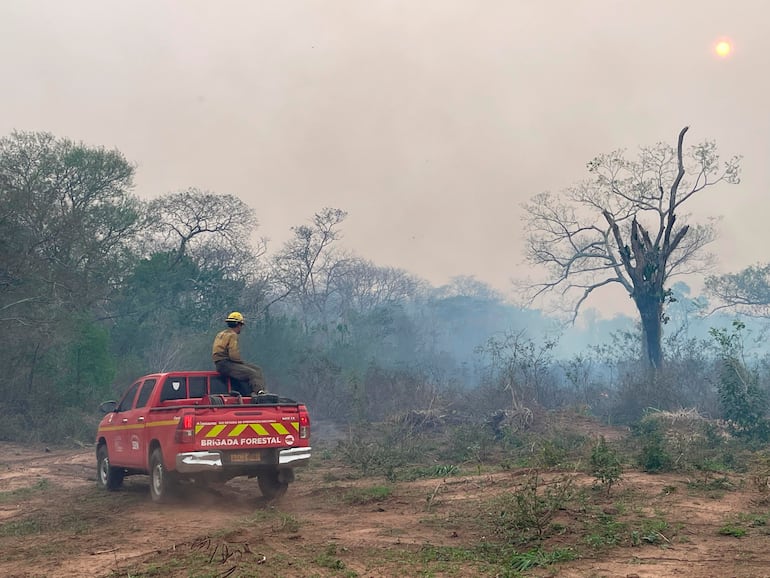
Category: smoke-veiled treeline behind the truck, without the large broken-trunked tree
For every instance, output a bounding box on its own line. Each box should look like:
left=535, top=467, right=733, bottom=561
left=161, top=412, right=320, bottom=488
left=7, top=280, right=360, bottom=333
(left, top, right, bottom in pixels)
left=0, top=132, right=764, bottom=442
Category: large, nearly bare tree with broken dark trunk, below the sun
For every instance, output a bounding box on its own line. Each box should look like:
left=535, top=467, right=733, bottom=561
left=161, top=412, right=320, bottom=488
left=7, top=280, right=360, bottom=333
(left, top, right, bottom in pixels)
left=524, top=127, right=740, bottom=368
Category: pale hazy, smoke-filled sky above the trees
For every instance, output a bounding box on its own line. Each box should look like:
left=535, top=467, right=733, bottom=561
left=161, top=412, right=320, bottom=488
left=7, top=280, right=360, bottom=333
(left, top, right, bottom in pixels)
left=0, top=0, right=770, bottom=316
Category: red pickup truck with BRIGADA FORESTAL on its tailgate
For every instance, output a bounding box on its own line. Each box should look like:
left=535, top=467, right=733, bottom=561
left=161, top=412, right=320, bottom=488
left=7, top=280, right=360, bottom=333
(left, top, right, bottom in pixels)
left=96, top=371, right=310, bottom=502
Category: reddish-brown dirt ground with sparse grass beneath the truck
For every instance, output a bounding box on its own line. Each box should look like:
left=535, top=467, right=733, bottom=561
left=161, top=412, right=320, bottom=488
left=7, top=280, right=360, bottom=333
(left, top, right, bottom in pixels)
left=0, top=426, right=770, bottom=578
